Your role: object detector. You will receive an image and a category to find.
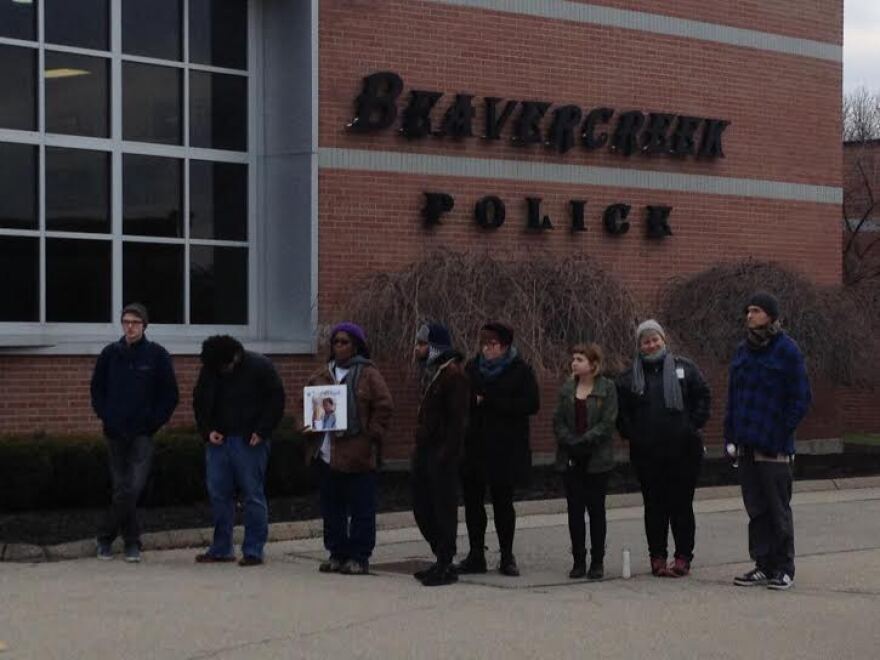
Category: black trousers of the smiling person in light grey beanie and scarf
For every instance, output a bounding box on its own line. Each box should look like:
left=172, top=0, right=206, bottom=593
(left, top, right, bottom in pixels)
left=633, top=456, right=702, bottom=561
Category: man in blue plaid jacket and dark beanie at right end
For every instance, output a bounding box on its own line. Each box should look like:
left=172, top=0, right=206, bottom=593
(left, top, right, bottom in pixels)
left=724, top=292, right=812, bottom=590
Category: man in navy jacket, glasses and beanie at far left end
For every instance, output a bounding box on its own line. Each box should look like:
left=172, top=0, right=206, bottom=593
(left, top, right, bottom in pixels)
left=91, top=303, right=178, bottom=562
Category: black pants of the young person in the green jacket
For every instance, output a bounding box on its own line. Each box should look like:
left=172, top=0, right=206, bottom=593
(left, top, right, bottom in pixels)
left=563, top=466, right=608, bottom=562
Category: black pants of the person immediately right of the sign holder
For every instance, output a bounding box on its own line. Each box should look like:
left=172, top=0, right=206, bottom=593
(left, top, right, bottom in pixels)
left=412, top=447, right=458, bottom=566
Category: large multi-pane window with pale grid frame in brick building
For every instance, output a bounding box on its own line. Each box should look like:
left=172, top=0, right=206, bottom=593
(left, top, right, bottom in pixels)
left=0, top=0, right=255, bottom=332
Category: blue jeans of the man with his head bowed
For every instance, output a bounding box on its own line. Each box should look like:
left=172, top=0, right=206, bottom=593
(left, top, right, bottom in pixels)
left=205, top=436, right=269, bottom=559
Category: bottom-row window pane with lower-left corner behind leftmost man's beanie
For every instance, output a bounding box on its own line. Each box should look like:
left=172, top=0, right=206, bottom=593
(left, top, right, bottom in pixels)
left=122, top=243, right=183, bottom=323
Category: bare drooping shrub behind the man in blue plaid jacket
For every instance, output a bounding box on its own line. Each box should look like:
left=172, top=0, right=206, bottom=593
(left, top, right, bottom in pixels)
left=662, top=260, right=880, bottom=384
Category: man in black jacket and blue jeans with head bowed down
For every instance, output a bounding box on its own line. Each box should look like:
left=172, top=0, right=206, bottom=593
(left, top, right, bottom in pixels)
left=193, top=335, right=284, bottom=566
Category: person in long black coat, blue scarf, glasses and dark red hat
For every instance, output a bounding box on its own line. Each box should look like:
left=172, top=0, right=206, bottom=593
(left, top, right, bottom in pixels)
left=457, top=322, right=540, bottom=576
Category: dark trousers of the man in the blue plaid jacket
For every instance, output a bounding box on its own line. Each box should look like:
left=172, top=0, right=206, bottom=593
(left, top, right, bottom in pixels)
left=739, top=454, right=794, bottom=577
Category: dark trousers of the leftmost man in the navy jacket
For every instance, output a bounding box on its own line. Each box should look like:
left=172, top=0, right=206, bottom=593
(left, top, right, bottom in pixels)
left=98, top=435, right=153, bottom=547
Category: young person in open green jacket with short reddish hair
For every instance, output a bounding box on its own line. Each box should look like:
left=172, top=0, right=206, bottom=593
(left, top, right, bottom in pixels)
left=553, top=344, right=617, bottom=580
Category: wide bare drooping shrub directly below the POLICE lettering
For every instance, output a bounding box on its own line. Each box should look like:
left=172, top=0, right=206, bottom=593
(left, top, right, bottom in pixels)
left=336, top=250, right=636, bottom=373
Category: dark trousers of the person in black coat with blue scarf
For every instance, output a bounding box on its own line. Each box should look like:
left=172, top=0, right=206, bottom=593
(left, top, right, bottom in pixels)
left=461, top=470, right=516, bottom=559
